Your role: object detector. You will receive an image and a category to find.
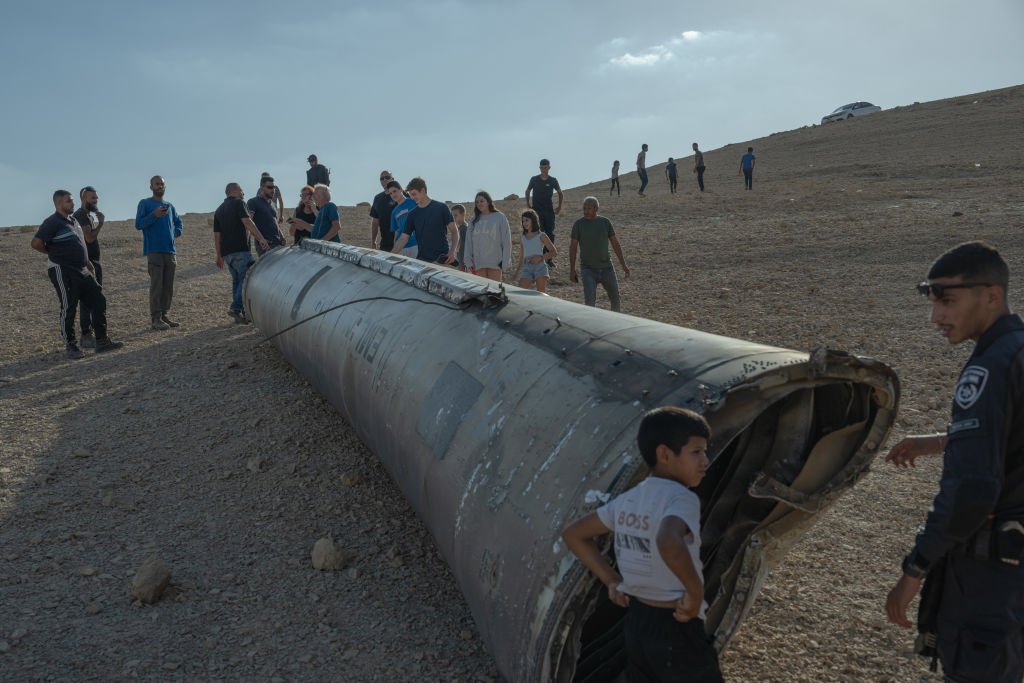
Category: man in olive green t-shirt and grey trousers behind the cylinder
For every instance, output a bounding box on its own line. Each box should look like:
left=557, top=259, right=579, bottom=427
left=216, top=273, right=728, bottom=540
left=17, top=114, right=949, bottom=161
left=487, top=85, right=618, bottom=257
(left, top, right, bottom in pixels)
left=569, top=197, right=630, bottom=310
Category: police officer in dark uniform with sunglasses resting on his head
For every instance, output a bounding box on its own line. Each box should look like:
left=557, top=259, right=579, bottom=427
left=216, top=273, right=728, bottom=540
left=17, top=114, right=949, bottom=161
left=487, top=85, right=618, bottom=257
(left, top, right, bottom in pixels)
left=886, top=242, right=1024, bottom=681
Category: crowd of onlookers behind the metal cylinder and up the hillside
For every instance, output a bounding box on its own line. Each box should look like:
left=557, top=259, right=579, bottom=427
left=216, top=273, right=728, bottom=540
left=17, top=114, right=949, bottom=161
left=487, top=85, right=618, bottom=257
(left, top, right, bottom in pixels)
left=33, top=142, right=755, bottom=350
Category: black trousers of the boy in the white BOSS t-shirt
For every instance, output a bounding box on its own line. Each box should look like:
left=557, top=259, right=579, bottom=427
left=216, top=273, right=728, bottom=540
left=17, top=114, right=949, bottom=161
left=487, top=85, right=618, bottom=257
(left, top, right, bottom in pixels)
left=623, top=598, right=723, bottom=683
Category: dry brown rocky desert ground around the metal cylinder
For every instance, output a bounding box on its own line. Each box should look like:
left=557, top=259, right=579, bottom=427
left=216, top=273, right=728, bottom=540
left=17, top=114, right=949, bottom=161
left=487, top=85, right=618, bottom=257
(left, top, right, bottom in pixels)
left=0, top=83, right=1024, bottom=681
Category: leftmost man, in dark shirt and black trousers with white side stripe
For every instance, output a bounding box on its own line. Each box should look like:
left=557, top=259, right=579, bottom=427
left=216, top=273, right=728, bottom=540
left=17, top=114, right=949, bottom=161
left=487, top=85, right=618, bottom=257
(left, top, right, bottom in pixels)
left=32, top=189, right=124, bottom=358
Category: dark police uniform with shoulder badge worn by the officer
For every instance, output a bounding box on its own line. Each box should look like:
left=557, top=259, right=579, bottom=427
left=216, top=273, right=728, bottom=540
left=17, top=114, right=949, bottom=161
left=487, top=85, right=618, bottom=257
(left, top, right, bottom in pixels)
left=905, top=315, right=1024, bottom=681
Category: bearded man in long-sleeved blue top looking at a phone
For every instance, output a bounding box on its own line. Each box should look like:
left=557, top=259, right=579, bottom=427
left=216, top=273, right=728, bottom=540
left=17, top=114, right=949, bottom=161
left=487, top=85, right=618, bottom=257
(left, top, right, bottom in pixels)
left=135, top=175, right=181, bottom=330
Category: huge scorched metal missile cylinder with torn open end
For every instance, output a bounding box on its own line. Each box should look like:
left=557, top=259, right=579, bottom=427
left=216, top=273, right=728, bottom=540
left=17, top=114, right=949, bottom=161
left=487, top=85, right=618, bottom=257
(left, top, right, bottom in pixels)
left=245, top=240, right=899, bottom=681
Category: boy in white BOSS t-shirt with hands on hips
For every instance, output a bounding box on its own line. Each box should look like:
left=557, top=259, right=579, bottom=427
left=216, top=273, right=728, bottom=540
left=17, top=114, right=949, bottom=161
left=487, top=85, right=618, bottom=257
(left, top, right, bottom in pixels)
left=562, top=405, right=723, bottom=681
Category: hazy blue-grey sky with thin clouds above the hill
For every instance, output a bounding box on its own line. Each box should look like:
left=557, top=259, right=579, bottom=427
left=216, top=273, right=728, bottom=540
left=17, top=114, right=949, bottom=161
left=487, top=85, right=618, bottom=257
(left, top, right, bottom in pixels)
left=0, top=0, right=1024, bottom=225
